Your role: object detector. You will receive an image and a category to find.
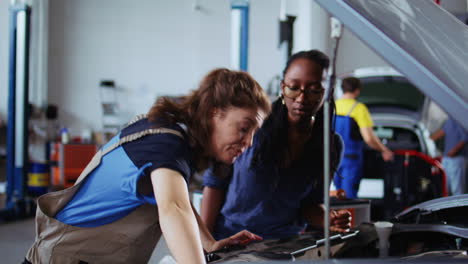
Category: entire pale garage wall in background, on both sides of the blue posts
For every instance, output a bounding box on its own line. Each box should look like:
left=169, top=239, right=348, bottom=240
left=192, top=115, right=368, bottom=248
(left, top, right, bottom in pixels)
left=0, top=0, right=466, bottom=138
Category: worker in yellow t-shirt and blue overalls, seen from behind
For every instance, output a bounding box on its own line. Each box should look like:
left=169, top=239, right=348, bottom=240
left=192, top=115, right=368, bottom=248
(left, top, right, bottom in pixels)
left=333, top=77, right=393, bottom=199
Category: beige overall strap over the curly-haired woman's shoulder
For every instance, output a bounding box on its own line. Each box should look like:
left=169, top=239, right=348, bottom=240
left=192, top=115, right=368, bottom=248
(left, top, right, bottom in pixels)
left=75, top=127, right=184, bottom=185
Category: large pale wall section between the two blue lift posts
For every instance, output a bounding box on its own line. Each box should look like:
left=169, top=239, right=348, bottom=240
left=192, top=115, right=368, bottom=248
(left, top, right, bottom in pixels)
left=49, top=0, right=229, bottom=134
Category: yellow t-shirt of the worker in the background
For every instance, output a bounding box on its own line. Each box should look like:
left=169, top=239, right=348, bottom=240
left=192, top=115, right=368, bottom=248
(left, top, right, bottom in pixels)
left=335, top=98, right=374, bottom=128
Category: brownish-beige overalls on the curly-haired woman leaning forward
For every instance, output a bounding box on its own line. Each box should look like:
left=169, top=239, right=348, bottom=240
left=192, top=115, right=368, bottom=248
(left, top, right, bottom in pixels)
left=26, top=116, right=184, bottom=264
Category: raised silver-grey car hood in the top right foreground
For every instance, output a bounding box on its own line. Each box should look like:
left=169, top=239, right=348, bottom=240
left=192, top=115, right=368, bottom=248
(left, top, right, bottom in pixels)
left=315, top=0, right=468, bottom=130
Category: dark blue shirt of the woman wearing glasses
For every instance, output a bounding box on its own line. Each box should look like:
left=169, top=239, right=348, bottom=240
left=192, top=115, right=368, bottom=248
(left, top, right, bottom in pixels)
left=203, top=129, right=343, bottom=239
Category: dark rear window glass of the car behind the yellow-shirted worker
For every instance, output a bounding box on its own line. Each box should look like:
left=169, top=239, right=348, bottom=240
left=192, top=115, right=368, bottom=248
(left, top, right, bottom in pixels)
left=359, top=76, right=425, bottom=112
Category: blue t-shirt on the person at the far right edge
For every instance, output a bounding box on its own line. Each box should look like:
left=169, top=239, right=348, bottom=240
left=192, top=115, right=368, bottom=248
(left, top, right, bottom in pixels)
left=442, top=118, right=468, bottom=156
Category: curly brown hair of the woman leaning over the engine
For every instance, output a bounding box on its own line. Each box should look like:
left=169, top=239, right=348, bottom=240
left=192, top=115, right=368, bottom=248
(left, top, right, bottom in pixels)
left=148, top=68, right=271, bottom=169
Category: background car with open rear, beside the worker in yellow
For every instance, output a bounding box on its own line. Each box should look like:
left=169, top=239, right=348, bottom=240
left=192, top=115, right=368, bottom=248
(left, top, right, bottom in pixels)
left=335, top=67, right=446, bottom=220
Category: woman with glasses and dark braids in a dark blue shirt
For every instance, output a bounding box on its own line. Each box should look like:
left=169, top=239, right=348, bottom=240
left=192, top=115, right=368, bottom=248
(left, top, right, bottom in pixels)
left=201, top=50, right=350, bottom=239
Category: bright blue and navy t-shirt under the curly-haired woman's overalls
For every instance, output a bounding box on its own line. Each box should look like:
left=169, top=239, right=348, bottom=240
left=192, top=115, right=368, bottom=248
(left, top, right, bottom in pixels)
left=56, top=119, right=193, bottom=227
